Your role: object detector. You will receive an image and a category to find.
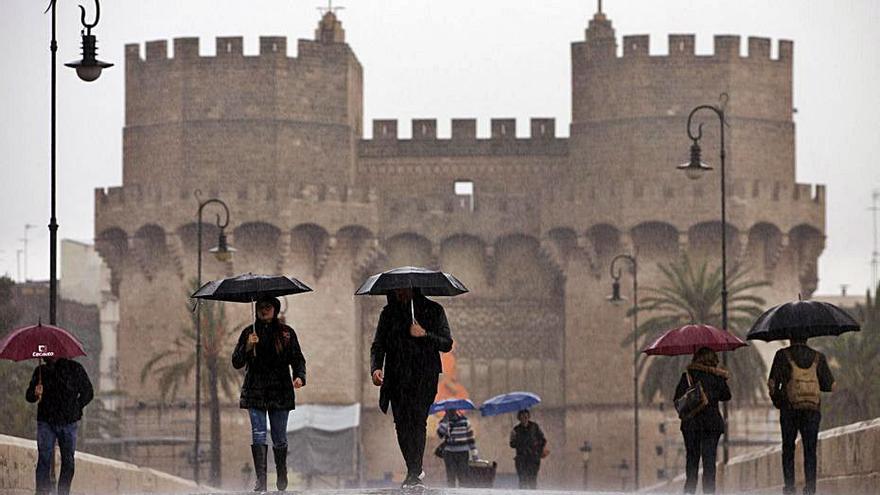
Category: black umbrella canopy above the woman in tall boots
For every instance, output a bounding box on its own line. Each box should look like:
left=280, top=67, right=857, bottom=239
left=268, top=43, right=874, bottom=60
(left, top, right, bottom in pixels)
left=191, top=273, right=312, bottom=302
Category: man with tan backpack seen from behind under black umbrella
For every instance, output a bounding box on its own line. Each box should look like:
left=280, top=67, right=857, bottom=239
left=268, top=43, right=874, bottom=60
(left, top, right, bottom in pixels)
left=767, top=339, right=834, bottom=495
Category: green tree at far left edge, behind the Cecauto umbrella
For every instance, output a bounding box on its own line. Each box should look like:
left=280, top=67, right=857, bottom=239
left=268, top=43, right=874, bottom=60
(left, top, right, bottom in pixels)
left=0, top=276, right=38, bottom=437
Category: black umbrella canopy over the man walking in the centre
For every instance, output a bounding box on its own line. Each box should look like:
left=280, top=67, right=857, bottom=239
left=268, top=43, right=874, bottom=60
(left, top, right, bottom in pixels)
left=355, top=266, right=468, bottom=296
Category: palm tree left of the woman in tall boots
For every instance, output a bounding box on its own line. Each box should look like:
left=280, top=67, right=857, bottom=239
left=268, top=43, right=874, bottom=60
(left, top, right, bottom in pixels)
left=141, top=281, right=241, bottom=486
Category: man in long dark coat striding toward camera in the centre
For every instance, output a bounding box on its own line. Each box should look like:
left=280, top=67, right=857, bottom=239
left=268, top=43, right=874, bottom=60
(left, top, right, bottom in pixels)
left=370, top=289, right=452, bottom=487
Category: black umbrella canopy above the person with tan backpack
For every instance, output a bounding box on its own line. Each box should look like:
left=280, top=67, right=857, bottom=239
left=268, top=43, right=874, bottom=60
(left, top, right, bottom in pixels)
left=746, top=301, right=860, bottom=342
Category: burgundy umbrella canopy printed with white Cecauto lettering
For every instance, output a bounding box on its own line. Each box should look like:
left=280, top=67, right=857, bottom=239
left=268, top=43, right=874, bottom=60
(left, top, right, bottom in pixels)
left=0, top=323, right=86, bottom=361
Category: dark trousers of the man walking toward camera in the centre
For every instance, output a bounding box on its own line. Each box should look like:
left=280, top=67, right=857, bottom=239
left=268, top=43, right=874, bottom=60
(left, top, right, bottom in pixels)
left=391, top=377, right=437, bottom=477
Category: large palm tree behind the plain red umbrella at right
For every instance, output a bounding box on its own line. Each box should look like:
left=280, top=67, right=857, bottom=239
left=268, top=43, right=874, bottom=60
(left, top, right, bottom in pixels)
left=623, top=255, right=769, bottom=404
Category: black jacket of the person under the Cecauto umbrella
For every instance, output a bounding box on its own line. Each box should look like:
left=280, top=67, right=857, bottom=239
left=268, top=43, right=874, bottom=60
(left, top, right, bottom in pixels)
left=25, top=359, right=95, bottom=425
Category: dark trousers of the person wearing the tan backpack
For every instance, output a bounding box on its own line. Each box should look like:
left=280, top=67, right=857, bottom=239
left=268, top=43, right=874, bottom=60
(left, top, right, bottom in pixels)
left=779, top=409, right=822, bottom=495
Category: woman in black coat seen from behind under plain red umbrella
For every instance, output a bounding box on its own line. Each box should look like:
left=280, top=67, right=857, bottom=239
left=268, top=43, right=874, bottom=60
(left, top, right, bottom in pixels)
left=675, top=347, right=730, bottom=493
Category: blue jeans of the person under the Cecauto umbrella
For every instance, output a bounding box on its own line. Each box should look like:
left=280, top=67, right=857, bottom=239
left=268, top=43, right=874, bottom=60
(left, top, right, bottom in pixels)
left=36, top=421, right=79, bottom=495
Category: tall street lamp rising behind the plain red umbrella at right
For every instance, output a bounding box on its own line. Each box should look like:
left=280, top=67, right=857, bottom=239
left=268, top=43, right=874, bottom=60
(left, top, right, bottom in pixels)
left=678, top=93, right=730, bottom=464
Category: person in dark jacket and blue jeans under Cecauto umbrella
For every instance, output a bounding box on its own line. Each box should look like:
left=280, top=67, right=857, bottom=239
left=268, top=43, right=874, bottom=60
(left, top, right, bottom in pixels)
left=25, top=358, right=94, bottom=495
